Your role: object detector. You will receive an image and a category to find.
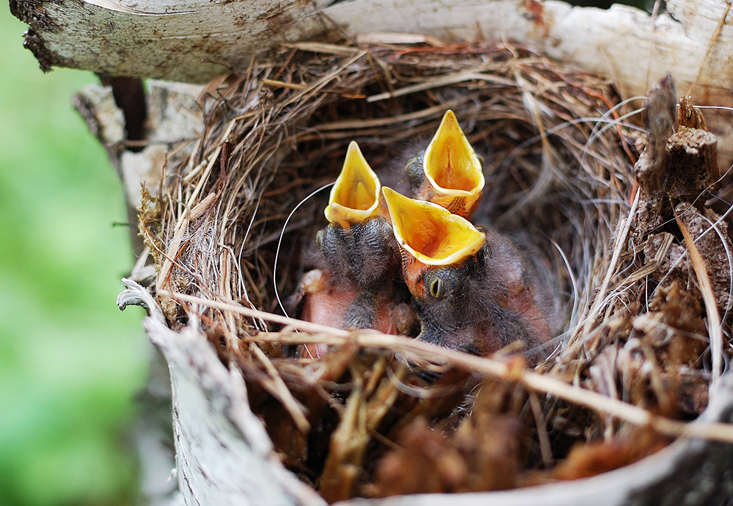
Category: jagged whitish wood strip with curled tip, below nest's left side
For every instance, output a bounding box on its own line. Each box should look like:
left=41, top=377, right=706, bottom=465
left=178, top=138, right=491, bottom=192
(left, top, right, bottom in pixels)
left=117, top=280, right=326, bottom=506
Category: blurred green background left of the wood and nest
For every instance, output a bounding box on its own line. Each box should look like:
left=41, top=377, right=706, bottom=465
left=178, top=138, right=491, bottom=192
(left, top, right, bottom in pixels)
left=0, top=2, right=149, bottom=506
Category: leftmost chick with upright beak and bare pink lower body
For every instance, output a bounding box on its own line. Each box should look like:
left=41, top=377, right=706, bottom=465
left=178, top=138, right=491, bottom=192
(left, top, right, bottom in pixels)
left=300, top=142, right=414, bottom=358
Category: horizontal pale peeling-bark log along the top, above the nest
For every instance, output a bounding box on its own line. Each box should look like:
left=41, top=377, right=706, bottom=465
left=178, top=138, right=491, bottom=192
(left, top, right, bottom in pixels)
left=11, top=0, right=733, bottom=103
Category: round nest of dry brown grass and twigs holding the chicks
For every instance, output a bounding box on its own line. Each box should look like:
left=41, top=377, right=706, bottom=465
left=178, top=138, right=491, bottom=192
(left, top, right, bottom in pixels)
left=140, top=41, right=731, bottom=502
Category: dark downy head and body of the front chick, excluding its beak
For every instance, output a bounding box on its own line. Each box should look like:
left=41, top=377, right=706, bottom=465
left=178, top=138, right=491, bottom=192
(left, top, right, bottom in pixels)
left=408, top=229, right=552, bottom=356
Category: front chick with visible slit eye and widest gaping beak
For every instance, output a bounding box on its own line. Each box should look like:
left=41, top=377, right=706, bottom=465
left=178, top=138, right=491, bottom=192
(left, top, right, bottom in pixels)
left=383, top=187, right=551, bottom=356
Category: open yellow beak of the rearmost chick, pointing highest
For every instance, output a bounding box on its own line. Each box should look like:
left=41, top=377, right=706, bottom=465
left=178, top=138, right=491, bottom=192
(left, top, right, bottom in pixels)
left=423, top=110, right=484, bottom=218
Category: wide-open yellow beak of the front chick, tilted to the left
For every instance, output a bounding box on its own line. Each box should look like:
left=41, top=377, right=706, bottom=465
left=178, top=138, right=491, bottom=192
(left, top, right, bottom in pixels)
left=383, top=187, right=486, bottom=265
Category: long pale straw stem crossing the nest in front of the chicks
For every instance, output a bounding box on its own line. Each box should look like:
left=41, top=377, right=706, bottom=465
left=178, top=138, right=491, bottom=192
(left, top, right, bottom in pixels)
left=159, top=290, right=733, bottom=443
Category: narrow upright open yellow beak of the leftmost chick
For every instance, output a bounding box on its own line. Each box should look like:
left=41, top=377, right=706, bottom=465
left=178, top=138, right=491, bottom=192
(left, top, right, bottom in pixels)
left=325, top=141, right=382, bottom=228
